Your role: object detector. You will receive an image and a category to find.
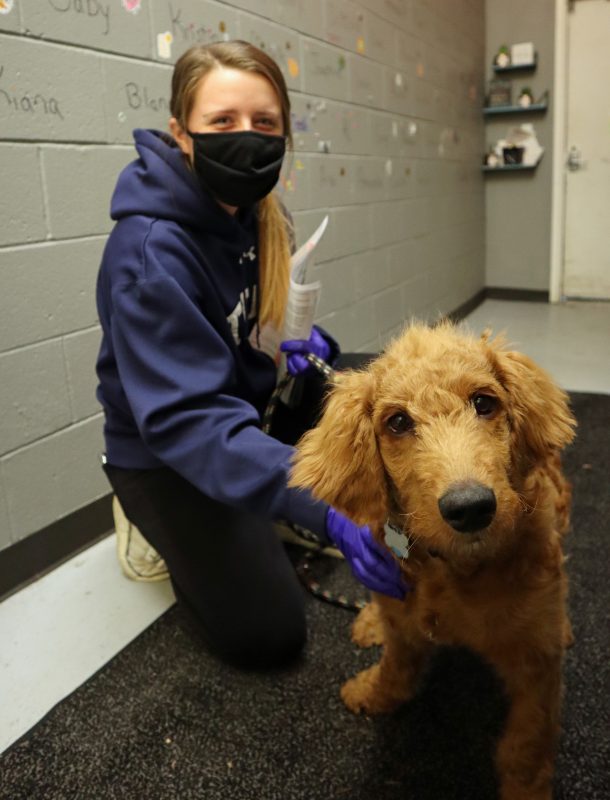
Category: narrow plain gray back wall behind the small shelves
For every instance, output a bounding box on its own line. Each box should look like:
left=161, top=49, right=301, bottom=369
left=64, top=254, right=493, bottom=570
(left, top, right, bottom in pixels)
left=485, top=0, right=555, bottom=291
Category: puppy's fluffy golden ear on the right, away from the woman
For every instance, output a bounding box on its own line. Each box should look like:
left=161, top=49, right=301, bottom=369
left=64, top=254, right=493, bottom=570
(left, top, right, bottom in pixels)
left=492, top=348, right=576, bottom=472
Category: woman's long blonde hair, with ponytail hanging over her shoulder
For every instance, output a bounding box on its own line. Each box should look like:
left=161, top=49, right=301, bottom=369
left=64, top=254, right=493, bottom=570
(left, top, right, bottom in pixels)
left=170, top=40, right=292, bottom=331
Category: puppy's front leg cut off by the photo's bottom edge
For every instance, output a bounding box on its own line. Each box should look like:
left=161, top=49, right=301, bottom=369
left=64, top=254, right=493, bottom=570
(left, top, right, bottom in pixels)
left=496, top=652, right=562, bottom=800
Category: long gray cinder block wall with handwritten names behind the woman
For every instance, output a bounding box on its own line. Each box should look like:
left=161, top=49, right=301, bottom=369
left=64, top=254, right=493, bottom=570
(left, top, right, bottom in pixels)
left=0, top=0, right=485, bottom=549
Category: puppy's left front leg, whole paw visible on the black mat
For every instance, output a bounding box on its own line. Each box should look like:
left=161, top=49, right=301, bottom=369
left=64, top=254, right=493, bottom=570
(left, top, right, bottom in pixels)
left=341, top=597, right=432, bottom=714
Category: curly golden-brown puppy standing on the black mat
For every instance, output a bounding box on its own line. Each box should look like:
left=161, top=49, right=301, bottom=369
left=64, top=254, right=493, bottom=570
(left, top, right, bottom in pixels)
left=292, top=323, right=576, bottom=800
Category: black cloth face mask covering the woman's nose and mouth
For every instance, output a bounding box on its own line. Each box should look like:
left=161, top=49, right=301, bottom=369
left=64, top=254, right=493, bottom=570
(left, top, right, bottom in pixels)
left=188, top=131, right=286, bottom=207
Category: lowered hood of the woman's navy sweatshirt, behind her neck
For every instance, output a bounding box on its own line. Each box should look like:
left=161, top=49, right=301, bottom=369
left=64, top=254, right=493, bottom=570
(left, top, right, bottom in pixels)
left=110, top=128, right=249, bottom=233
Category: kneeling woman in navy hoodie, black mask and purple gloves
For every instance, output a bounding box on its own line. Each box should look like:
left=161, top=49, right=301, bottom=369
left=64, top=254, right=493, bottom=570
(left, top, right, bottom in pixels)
left=97, top=41, right=404, bottom=667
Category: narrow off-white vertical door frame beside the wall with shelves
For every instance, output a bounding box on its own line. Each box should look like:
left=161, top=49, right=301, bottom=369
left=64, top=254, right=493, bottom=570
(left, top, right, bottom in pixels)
left=549, top=0, right=570, bottom=303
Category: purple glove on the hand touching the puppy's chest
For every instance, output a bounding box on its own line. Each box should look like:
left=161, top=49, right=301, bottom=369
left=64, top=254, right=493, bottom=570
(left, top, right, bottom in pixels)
left=326, top=507, right=407, bottom=600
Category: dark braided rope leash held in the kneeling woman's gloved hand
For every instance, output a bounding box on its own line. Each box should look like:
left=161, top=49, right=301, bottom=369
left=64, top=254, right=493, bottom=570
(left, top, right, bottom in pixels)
left=262, top=353, right=366, bottom=611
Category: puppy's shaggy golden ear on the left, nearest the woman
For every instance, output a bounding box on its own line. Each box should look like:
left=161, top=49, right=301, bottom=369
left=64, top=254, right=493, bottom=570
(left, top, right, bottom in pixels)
left=290, top=371, right=388, bottom=526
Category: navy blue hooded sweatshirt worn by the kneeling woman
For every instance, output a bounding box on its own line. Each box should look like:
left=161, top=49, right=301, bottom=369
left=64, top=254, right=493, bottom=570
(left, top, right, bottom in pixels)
left=97, top=130, right=327, bottom=534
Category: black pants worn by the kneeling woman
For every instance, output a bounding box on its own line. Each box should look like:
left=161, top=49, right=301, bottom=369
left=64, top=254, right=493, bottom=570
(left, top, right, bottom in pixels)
left=104, top=354, right=370, bottom=668
